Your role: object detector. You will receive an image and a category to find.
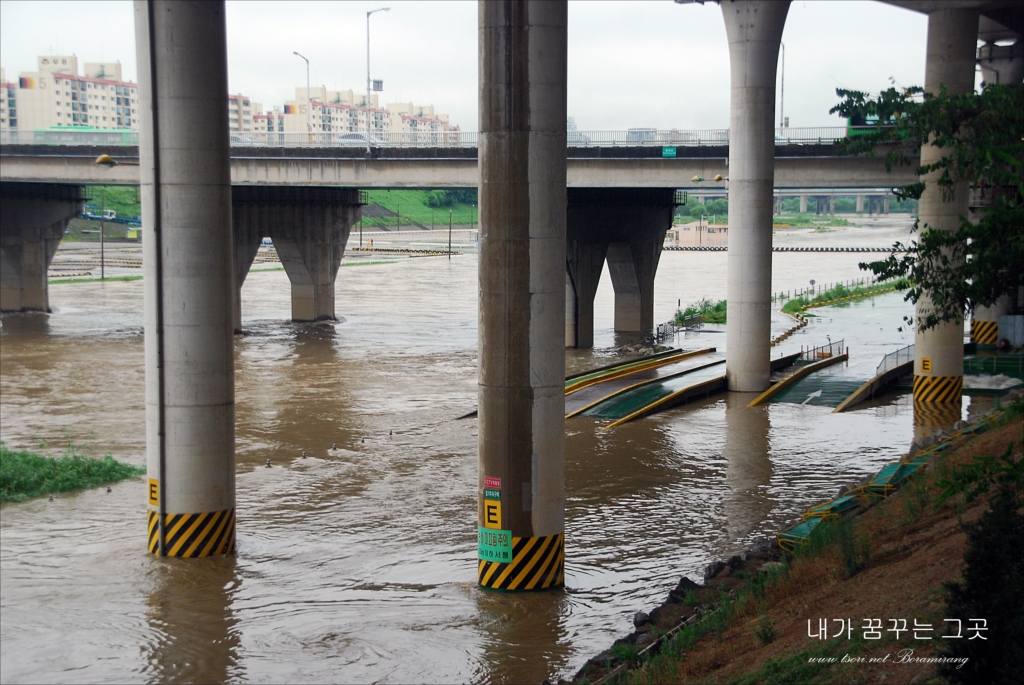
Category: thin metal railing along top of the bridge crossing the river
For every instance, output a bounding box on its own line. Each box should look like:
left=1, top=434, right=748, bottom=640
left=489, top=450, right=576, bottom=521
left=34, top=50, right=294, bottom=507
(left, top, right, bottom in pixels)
left=0, top=126, right=872, bottom=149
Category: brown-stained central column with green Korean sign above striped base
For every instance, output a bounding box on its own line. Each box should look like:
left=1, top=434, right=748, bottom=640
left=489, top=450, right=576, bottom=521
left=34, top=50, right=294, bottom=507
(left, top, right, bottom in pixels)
left=477, top=0, right=567, bottom=591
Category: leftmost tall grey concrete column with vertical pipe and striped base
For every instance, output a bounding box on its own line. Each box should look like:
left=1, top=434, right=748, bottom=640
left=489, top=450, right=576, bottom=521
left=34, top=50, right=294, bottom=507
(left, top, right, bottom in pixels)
left=135, top=0, right=234, bottom=557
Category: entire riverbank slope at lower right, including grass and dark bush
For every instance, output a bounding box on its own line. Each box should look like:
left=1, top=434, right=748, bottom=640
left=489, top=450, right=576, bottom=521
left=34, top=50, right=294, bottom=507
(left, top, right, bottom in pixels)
left=571, top=392, right=1024, bottom=685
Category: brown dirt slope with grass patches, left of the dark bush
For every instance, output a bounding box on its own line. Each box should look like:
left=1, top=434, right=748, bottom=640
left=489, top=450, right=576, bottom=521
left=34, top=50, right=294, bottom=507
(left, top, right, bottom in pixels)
left=585, top=401, right=1024, bottom=685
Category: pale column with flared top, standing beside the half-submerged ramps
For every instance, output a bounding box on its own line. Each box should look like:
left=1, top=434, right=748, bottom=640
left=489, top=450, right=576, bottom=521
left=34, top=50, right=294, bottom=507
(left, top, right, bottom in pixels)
left=722, top=0, right=790, bottom=392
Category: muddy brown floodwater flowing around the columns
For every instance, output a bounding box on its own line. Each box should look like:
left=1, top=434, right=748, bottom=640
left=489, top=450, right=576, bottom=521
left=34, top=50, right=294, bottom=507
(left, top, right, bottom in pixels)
left=0, top=239, right=978, bottom=683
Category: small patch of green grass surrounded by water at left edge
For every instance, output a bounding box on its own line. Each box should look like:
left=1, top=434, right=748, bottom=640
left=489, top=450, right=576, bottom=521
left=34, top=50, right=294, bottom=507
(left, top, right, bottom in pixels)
left=0, top=441, right=145, bottom=502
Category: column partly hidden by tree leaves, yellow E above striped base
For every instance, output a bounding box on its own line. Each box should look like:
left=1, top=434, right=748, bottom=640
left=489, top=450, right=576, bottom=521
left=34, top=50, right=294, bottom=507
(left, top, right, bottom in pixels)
left=913, top=9, right=978, bottom=416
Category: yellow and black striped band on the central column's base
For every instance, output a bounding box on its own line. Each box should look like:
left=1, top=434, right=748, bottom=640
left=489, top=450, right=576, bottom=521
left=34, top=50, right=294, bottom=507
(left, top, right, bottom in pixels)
left=477, top=532, right=565, bottom=592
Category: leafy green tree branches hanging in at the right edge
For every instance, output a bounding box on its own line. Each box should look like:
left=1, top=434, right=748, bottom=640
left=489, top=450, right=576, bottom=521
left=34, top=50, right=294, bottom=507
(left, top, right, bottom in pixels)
left=830, top=84, right=1024, bottom=330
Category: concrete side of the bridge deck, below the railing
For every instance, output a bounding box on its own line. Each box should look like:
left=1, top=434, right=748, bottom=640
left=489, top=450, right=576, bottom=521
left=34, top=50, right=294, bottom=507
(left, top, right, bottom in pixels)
left=0, top=143, right=916, bottom=189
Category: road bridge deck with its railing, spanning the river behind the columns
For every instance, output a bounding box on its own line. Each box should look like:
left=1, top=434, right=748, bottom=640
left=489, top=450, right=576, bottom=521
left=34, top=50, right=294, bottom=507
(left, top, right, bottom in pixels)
left=0, top=127, right=916, bottom=188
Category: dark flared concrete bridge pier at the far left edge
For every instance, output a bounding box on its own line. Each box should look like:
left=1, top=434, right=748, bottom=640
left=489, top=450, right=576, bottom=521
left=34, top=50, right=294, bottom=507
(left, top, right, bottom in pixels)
left=0, top=182, right=85, bottom=311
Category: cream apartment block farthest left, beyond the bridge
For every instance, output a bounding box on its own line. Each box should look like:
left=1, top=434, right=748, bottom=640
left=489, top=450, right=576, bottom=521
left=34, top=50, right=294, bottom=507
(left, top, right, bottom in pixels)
left=8, top=55, right=138, bottom=130
